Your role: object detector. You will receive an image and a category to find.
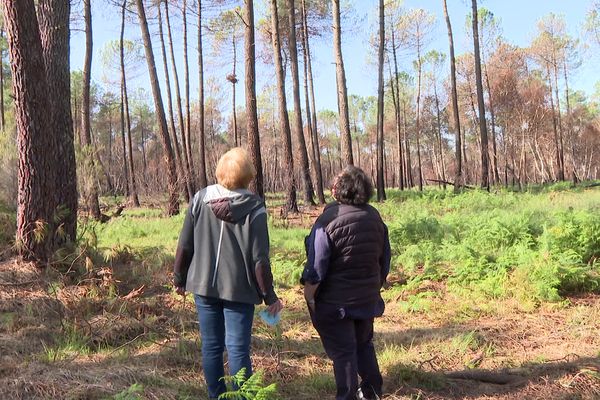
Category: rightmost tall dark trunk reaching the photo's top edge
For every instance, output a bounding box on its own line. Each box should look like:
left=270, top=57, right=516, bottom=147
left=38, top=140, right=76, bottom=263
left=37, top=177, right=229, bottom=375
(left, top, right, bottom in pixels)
left=471, top=0, right=490, bottom=190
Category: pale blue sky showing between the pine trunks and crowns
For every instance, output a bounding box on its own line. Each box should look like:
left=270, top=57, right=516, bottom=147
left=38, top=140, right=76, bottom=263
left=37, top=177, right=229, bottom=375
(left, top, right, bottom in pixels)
left=71, top=0, right=600, bottom=110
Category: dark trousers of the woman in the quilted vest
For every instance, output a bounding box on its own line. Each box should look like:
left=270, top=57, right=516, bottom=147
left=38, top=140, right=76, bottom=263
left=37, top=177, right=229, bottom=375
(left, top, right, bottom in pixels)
left=311, top=303, right=383, bottom=400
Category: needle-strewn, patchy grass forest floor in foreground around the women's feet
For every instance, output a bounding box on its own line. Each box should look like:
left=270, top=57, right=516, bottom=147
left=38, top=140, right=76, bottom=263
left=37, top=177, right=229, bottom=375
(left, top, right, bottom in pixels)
left=0, top=188, right=600, bottom=400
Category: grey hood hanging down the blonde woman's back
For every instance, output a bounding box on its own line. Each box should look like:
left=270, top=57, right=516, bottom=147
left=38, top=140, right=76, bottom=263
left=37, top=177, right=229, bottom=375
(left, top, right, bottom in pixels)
left=203, top=185, right=264, bottom=222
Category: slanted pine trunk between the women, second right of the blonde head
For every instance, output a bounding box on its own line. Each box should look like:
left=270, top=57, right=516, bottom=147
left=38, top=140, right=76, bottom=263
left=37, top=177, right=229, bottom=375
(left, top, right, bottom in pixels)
left=271, top=0, right=298, bottom=212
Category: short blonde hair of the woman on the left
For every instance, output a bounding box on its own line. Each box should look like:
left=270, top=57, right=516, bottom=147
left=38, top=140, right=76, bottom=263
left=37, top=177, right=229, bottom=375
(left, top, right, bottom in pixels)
left=216, top=147, right=256, bottom=190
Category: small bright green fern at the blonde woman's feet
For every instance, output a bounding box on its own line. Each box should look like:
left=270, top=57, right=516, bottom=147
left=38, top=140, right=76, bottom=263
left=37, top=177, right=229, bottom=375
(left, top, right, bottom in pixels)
left=219, top=368, right=279, bottom=400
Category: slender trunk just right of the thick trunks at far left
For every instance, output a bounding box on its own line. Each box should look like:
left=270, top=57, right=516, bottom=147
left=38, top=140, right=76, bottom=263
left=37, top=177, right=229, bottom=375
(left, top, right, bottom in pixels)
left=81, top=0, right=101, bottom=221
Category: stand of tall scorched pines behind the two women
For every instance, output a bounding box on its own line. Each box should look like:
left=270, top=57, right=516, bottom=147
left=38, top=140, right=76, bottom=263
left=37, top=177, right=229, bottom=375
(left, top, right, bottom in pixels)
left=0, top=0, right=600, bottom=260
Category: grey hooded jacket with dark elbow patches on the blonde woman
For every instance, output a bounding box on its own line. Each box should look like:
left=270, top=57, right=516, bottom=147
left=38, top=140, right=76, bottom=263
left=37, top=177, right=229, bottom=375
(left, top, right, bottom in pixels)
left=174, top=185, right=277, bottom=305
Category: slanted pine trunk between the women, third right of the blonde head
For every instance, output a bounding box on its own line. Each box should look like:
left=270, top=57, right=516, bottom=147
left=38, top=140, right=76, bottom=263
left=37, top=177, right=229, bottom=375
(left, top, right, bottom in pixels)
left=287, top=0, right=315, bottom=206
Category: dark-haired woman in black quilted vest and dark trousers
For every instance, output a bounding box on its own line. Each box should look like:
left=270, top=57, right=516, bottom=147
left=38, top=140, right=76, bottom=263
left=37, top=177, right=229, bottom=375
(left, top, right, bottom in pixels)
left=302, top=166, right=391, bottom=400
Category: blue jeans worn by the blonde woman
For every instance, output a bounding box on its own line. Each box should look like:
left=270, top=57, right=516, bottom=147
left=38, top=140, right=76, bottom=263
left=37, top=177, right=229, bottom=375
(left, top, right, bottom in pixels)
left=194, top=294, right=254, bottom=399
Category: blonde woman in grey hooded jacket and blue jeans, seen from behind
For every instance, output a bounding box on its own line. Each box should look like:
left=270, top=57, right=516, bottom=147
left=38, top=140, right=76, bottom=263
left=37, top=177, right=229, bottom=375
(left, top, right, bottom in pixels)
left=174, top=147, right=283, bottom=399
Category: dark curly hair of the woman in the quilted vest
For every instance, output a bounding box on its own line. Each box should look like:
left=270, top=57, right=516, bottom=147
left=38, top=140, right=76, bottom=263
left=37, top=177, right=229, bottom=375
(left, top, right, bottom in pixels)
left=332, top=165, right=373, bottom=206
